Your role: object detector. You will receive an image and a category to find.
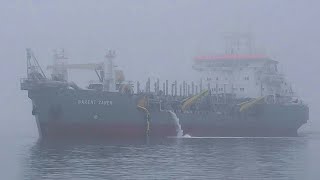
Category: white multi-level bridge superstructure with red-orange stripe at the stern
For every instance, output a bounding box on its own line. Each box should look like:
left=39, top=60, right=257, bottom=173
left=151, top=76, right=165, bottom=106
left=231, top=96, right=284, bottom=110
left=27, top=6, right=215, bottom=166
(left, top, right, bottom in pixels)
left=193, top=54, right=292, bottom=98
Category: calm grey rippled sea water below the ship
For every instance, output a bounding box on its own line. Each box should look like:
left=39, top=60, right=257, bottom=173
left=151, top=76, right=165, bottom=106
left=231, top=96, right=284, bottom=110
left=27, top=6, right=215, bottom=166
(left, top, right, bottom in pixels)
left=0, top=133, right=320, bottom=180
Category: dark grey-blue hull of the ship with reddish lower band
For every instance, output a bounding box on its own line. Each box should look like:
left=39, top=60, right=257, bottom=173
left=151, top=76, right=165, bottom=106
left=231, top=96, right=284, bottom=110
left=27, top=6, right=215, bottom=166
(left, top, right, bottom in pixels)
left=29, top=88, right=309, bottom=139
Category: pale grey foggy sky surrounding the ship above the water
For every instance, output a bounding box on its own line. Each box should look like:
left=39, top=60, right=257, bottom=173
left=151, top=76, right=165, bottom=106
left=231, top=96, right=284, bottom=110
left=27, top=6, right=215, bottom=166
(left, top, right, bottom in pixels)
left=0, top=0, right=320, bottom=136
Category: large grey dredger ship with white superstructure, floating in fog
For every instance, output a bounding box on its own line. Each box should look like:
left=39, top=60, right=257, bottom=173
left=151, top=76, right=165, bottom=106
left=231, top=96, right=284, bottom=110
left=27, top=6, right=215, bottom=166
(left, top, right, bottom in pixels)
left=21, top=38, right=309, bottom=138
